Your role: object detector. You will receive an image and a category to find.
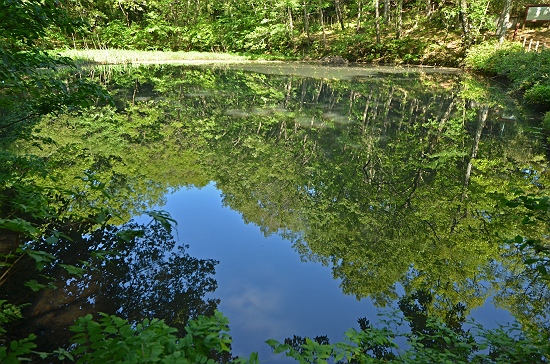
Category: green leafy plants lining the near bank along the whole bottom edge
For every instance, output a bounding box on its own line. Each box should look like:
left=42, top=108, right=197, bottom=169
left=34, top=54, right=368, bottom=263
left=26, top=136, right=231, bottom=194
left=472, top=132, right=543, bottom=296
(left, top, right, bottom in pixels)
left=0, top=312, right=550, bottom=364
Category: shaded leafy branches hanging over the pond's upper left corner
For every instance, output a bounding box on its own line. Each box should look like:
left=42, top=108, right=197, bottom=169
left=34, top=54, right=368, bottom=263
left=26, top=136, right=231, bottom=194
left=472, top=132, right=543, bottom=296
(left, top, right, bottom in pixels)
left=0, top=0, right=112, bottom=132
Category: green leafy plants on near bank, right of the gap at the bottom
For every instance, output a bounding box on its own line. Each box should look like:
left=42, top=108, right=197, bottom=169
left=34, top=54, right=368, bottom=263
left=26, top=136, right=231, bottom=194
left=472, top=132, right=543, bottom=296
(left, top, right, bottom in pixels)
left=267, top=319, right=550, bottom=364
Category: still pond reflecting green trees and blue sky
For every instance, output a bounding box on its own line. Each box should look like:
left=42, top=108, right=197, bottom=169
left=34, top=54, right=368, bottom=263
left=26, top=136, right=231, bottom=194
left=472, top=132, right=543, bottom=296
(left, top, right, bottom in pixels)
left=0, top=63, right=550, bottom=362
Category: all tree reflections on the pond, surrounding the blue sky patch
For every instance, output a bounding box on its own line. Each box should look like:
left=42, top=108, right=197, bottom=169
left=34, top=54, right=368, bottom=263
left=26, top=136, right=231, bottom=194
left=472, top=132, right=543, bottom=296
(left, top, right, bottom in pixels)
left=2, top=64, right=549, bottom=358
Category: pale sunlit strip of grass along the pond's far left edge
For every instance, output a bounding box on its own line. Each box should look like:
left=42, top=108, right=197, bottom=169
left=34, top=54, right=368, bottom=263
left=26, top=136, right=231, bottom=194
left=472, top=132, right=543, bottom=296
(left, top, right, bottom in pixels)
left=54, top=49, right=249, bottom=64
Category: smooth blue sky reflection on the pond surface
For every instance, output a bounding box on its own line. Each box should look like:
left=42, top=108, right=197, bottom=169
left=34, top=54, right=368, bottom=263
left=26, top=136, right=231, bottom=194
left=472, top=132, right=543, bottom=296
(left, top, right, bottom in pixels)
left=162, top=183, right=512, bottom=362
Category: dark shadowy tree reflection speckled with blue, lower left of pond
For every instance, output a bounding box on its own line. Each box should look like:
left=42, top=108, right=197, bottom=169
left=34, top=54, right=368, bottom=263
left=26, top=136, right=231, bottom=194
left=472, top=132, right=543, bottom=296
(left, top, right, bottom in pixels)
left=4, top=222, right=219, bottom=350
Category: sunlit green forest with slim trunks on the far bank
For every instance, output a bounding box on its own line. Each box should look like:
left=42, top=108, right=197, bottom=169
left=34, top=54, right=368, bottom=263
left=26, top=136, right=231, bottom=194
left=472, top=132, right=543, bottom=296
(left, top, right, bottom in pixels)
left=36, top=0, right=545, bottom=64
